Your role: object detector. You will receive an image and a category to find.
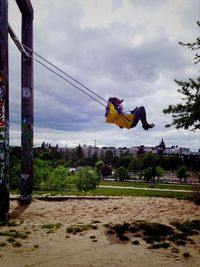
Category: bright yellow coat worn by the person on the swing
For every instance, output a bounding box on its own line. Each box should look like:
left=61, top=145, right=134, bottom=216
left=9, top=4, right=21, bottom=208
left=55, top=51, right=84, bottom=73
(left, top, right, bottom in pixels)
left=106, top=103, right=134, bottom=129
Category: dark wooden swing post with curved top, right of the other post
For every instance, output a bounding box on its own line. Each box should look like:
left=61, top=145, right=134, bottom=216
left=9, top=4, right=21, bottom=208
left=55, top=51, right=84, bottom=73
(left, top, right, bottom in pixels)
left=16, top=0, right=33, bottom=204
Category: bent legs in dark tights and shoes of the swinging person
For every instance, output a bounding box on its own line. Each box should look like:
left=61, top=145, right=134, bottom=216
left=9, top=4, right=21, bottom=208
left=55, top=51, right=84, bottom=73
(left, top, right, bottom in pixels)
left=131, top=106, right=155, bottom=130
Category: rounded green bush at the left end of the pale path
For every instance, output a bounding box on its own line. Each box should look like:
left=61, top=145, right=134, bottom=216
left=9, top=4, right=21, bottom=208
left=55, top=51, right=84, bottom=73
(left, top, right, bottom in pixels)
left=74, top=166, right=100, bottom=192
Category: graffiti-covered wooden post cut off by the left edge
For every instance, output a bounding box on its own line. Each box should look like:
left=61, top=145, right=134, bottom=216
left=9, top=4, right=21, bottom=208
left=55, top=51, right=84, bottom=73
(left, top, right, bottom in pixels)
left=0, top=0, right=9, bottom=221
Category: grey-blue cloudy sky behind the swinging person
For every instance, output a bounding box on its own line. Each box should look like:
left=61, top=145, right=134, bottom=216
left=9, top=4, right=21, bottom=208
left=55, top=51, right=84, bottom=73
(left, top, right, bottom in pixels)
left=8, top=0, right=200, bottom=151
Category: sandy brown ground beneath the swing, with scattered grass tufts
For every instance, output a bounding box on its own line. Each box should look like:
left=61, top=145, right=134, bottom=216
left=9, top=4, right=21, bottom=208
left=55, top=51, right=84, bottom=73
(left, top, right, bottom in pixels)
left=0, top=197, right=200, bottom=267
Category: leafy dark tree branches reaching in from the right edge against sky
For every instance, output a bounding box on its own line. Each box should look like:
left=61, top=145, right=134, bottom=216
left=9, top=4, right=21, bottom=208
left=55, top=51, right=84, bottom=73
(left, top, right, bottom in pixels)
left=163, top=21, right=200, bottom=131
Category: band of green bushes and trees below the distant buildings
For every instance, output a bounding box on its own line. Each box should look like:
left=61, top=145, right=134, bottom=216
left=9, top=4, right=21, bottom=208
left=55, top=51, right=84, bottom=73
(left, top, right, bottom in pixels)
left=9, top=147, right=200, bottom=191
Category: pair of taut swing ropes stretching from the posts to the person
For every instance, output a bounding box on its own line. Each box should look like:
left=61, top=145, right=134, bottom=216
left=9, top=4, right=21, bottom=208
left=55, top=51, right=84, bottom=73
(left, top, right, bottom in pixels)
left=8, top=25, right=107, bottom=107
